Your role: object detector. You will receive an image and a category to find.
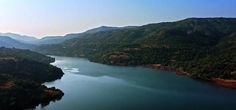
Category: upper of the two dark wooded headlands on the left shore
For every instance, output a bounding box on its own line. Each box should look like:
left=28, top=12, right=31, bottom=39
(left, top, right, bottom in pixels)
left=0, top=47, right=63, bottom=83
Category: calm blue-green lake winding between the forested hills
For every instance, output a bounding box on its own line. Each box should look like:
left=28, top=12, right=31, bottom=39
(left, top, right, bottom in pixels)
left=36, top=56, right=236, bottom=110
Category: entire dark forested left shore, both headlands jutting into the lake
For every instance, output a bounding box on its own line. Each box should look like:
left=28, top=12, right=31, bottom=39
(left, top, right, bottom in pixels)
left=0, top=48, right=64, bottom=110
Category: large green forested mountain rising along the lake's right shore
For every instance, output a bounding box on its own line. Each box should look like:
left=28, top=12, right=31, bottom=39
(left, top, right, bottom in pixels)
left=35, top=18, right=236, bottom=80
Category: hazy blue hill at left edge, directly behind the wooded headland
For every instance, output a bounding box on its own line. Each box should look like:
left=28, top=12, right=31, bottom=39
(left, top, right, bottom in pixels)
left=0, top=36, right=34, bottom=49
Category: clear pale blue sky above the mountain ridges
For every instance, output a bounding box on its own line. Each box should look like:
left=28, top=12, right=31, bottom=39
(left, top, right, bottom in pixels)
left=0, top=0, right=236, bottom=38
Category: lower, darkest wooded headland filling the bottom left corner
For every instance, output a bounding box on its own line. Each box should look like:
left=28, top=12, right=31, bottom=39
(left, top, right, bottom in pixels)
left=0, top=77, right=64, bottom=110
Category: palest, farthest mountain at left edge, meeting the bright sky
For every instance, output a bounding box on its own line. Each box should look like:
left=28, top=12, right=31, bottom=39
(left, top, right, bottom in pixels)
left=0, top=33, right=37, bottom=44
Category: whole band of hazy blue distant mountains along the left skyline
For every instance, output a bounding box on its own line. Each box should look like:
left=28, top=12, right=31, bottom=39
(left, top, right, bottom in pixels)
left=0, top=26, right=120, bottom=48
